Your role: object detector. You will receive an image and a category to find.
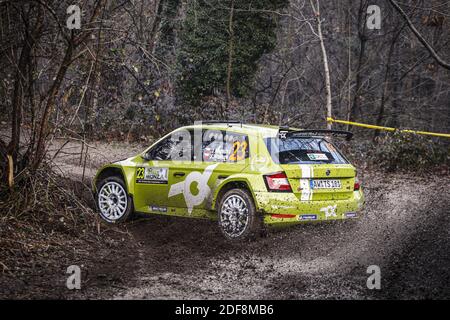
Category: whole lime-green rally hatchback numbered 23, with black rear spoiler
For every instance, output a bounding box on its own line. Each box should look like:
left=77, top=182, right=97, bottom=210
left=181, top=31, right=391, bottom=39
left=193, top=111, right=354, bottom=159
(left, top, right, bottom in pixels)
left=93, top=121, right=364, bottom=240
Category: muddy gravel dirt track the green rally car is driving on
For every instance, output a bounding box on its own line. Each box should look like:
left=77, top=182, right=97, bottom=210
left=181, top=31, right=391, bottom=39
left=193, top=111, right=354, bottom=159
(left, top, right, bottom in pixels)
left=26, top=139, right=450, bottom=299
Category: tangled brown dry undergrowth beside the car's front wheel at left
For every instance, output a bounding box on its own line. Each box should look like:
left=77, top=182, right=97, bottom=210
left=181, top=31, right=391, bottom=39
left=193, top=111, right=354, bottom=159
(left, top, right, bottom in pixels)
left=0, top=164, right=126, bottom=288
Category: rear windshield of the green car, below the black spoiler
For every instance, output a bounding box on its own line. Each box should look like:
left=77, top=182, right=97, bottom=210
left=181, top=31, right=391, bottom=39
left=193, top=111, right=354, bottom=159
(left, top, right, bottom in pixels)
left=264, top=137, right=348, bottom=164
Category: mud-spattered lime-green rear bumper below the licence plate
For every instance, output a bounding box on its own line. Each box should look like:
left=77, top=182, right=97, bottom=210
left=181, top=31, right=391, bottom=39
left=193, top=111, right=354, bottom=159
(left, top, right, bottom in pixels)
left=255, top=190, right=364, bottom=224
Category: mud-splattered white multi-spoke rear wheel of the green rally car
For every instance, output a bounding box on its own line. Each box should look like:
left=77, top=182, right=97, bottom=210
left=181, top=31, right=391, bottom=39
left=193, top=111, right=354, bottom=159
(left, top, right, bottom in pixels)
left=217, top=189, right=262, bottom=241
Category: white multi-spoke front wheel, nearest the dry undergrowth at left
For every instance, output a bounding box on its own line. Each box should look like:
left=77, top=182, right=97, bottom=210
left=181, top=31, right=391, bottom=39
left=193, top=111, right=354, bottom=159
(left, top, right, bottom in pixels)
left=96, top=177, right=133, bottom=223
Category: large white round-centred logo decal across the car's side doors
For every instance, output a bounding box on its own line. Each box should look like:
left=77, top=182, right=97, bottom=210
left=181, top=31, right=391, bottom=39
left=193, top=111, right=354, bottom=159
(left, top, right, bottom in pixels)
left=169, top=164, right=218, bottom=214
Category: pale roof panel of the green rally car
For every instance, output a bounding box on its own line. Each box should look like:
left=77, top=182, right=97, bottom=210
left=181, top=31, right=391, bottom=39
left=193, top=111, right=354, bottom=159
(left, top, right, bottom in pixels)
left=178, top=122, right=280, bottom=137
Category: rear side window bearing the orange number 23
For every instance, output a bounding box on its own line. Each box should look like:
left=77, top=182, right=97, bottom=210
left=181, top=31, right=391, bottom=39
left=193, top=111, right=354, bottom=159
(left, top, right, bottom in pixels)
left=202, top=130, right=249, bottom=162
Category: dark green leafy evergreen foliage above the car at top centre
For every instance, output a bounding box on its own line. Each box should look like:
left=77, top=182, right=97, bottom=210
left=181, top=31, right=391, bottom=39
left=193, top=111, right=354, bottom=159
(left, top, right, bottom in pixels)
left=178, top=0, right=288, bottom=103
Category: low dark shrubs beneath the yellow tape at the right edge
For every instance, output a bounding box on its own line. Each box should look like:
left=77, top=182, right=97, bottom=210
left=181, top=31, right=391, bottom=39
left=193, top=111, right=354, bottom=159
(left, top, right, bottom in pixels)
left=370, top=133, right=450, bottom=171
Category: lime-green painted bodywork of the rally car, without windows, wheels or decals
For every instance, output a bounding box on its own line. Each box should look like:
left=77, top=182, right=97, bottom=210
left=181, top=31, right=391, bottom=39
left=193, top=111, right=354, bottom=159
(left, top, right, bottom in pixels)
left=93, top=124, right=364, bottom=224
